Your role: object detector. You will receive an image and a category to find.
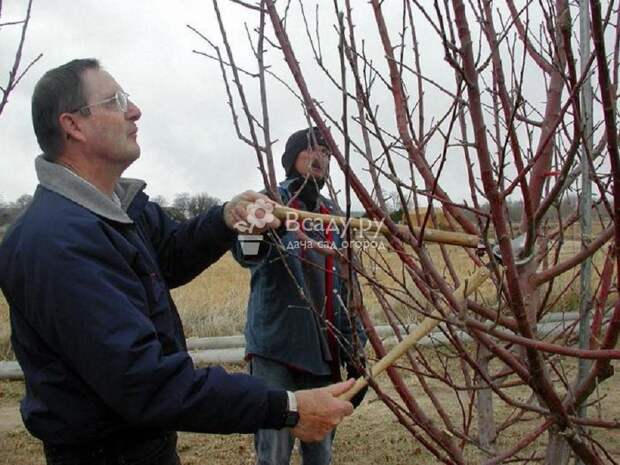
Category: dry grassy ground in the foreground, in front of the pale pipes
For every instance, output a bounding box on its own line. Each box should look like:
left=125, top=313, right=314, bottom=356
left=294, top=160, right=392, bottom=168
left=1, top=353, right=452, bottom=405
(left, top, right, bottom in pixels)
left=0, top=353, right=620, bottom=465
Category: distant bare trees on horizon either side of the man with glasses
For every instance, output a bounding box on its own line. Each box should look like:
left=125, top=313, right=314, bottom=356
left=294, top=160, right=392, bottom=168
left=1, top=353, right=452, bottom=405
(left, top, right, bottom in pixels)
left=0, top=192, right=221, bottom=232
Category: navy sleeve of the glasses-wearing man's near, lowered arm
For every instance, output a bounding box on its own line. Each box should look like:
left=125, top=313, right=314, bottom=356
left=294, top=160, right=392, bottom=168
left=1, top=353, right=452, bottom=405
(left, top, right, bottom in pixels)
left=29, top=216, right=286, bottom=433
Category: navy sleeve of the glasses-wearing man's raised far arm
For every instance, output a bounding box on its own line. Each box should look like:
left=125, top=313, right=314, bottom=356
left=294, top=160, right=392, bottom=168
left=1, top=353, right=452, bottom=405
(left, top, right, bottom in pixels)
left=143, top=202, right=237, bottom=288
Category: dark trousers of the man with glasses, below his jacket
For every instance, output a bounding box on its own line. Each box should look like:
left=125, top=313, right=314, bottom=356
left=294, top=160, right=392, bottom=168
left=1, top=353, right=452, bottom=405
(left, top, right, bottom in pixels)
left=43, top=433, right=181, bottom=465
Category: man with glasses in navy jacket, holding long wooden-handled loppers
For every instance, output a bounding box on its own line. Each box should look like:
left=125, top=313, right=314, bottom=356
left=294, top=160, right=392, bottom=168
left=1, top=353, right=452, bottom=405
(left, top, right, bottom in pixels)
left=0, top=59, right=352, bottom=465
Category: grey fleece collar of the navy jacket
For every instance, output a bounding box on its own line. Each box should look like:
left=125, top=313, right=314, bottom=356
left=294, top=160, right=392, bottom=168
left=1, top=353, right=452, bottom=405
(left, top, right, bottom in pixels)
left=34, top=155, right=146, bottom=223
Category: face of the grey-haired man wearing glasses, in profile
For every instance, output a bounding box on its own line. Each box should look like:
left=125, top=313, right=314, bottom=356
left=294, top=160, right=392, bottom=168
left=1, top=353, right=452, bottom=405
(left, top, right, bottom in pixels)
left=82, top=69, right=142, bottom=168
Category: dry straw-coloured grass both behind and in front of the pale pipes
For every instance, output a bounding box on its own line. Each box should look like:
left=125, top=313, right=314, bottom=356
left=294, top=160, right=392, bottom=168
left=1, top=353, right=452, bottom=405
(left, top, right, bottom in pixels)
left=0, top=237, right=620, bottom=465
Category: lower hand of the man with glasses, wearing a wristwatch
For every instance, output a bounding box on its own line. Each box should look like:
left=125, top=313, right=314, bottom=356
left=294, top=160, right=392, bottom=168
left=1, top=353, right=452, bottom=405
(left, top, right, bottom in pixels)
left=291, top=379, right=355, bottom=442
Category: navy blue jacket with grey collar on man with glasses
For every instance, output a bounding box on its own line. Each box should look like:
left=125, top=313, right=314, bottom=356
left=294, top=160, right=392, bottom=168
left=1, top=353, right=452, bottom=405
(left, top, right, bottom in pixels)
left=0, top=177, right=286, bottom=444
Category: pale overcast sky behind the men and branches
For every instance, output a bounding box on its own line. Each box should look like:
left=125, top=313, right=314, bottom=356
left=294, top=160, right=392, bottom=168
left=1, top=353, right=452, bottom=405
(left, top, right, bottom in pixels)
left=0, top=0, right=592, bottom=207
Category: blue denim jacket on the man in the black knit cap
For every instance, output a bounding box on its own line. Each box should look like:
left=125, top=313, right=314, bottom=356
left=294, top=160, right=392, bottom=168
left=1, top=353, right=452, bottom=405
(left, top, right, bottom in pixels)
left=233, top=179, right=366, bottom=376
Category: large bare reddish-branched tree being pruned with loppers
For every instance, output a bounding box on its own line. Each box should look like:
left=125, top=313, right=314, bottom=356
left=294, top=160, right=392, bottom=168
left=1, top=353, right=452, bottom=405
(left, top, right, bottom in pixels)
left=194, top=0, right=620, bottom=465
